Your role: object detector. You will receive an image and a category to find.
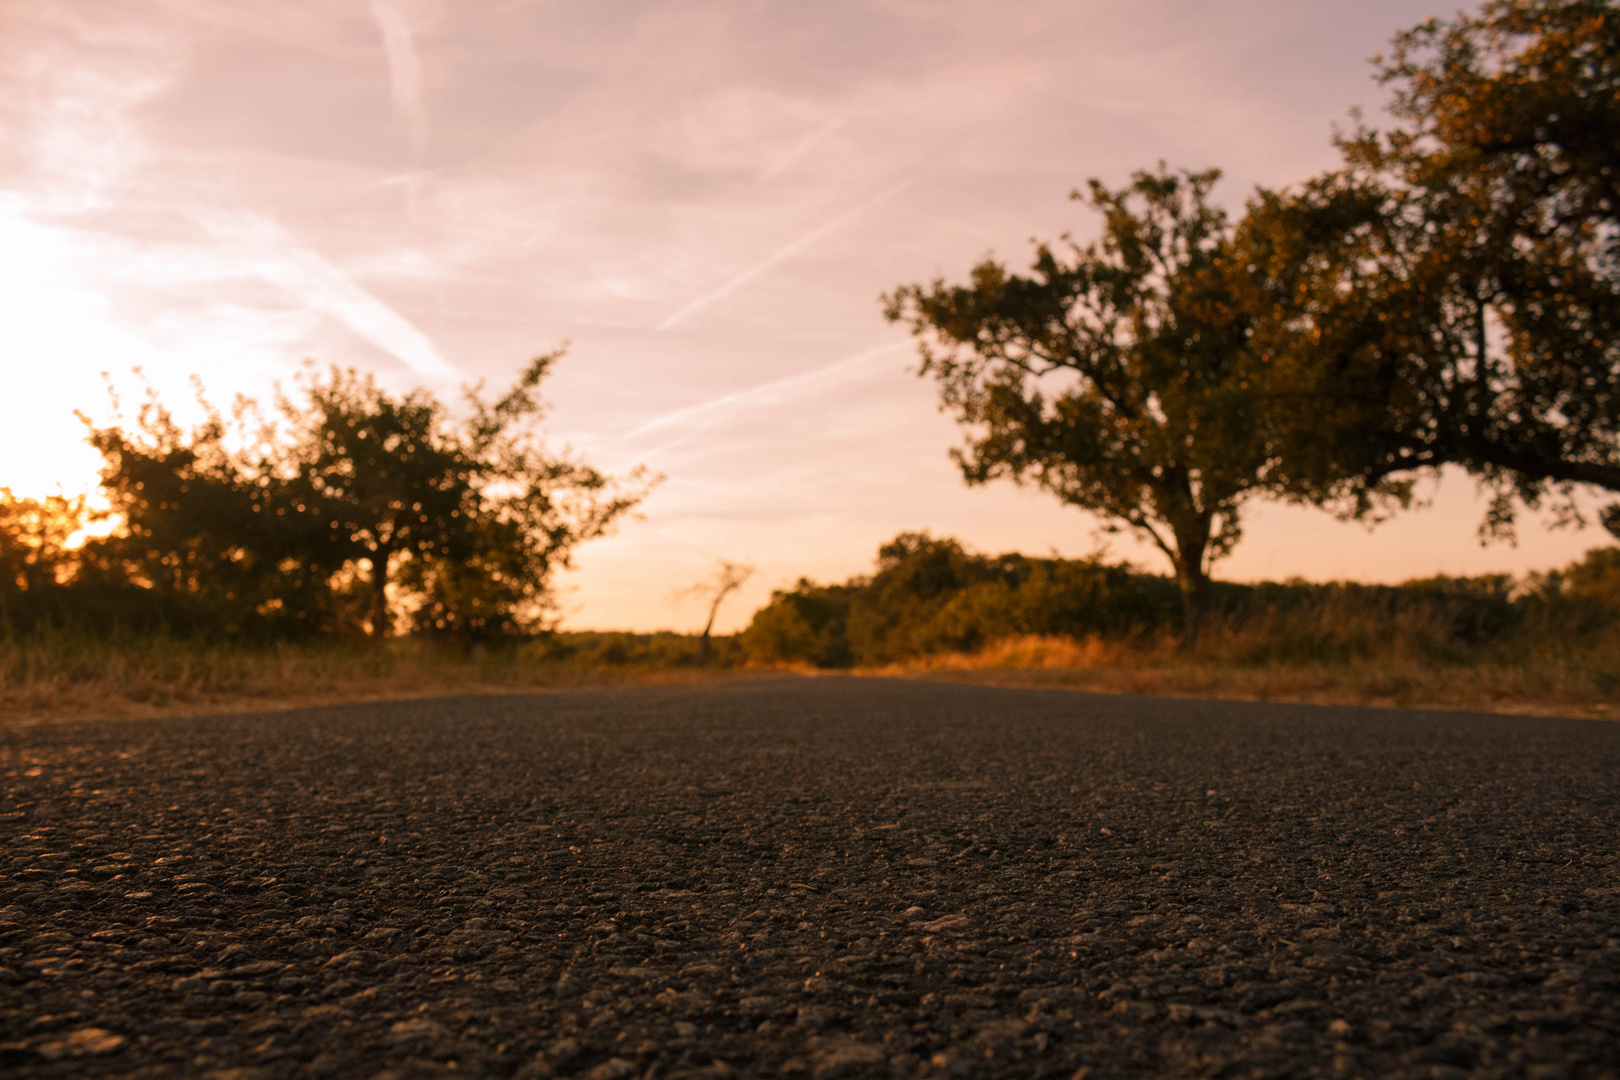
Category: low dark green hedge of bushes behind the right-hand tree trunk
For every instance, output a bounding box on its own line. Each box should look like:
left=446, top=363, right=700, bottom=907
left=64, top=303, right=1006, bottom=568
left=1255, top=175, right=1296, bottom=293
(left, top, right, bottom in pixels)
left=740, top=533, right=1620, bottom=667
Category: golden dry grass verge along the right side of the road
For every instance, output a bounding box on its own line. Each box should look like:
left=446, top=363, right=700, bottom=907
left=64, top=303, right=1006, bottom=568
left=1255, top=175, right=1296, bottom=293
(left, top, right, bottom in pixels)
left=862, top=636, right=1620, bottom=719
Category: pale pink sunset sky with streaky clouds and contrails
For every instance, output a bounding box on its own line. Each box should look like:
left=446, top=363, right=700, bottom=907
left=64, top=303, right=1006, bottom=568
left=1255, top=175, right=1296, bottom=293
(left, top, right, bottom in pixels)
left=0, top=0, right=1605, bottom=631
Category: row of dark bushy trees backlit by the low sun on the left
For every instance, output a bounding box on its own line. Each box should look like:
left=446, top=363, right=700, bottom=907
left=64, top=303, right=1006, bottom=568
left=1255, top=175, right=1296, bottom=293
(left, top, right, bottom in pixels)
left=0, top=350, right=656, bottom=644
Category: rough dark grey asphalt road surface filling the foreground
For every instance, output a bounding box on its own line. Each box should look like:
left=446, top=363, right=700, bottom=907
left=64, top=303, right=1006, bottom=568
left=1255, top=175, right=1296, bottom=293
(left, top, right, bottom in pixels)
left=0, top=678, right=1620, bottom=1080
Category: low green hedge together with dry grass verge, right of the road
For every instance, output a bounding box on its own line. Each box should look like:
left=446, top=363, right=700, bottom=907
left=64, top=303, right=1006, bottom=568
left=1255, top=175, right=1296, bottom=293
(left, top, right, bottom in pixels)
left=739, top=533, right=1620, bottom=716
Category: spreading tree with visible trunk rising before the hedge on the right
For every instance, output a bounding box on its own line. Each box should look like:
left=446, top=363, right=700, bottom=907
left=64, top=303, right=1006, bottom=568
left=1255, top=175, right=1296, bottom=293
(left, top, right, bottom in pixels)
left=885, top=165, right=1270, bottom=643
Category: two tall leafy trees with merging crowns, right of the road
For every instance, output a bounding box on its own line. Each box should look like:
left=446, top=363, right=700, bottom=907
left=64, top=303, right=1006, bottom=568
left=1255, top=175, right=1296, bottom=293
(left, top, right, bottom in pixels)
left=885, top=0, right=1620, bottom=640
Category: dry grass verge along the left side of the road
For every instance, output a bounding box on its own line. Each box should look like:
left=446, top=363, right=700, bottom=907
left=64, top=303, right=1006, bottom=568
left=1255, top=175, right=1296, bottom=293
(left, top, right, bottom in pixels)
left=0, top=638, right=771, bottom=724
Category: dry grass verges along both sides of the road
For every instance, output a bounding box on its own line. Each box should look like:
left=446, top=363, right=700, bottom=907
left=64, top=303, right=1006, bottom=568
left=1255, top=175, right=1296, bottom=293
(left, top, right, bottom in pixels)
left=0, top=635, right=1620, bottom=724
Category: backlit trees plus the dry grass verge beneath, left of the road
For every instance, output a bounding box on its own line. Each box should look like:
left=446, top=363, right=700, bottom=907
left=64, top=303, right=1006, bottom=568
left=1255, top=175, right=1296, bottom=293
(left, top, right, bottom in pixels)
left=0, top=351, right=699, bottom=721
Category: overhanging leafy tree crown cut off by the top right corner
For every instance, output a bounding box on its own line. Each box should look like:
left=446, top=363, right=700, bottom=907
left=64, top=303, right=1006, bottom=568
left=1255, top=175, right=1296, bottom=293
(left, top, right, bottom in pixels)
left=1239, top=0, right=1620, bottom=536
